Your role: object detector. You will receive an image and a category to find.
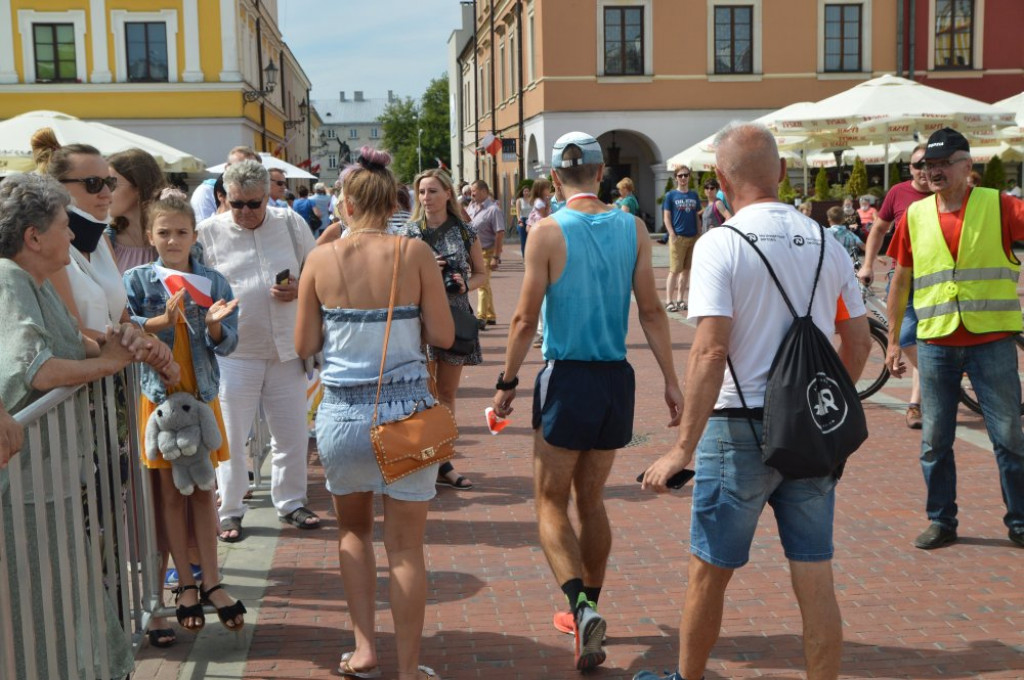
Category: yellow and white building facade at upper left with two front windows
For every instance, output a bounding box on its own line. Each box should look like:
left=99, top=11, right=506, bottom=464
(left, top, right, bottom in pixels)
left=0, top=0, right=315, bottom=170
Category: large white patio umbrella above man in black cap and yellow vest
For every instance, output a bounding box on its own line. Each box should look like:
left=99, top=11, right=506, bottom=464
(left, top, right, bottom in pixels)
left=773, top=75, right=1015, bottom=188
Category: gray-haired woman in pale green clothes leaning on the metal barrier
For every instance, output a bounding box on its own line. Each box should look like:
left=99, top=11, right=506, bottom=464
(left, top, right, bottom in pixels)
left=0, top=174, right=146, bottom=678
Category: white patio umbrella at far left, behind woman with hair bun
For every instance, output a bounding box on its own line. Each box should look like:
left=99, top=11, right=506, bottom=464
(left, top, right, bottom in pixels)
left=0, top=111, right=205, bottom=174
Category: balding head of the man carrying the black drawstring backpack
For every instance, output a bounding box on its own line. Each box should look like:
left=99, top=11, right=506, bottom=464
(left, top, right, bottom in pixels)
left=715, top=122, right=783, bottom=197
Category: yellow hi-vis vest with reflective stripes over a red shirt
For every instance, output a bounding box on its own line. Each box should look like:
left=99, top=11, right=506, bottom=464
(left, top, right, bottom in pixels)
left=906, top=187, right=1022, bottom=340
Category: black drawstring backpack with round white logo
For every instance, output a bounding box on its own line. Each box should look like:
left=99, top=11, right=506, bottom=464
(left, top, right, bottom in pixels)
left=723, top=224, right=867, bottom=479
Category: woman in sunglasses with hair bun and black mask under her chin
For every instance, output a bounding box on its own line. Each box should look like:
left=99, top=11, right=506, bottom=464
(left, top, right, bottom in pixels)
left=32, top=128, right=179, bottom=376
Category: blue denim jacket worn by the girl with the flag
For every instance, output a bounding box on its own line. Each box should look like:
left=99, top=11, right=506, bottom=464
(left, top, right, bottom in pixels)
left=124, top=257, right=239, bottom=403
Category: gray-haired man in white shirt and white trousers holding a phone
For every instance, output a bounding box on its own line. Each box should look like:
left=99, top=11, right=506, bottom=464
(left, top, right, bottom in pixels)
left=193, top=161, right=319, bottom=543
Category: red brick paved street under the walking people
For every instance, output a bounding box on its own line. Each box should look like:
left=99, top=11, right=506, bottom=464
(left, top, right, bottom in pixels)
left=135, top=245, right=1024, bottom=680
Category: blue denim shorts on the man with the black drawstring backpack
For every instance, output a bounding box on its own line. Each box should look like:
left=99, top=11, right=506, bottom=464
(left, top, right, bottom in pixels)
left=690, top=417, right=836, bottom=569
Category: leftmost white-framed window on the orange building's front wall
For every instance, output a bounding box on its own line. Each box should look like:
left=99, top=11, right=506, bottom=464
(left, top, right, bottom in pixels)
left=597, top=0, right=654, bottom=77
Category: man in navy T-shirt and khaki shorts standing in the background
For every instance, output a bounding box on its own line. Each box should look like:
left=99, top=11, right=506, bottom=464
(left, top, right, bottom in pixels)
left=662, top=165, right=700, bottom=311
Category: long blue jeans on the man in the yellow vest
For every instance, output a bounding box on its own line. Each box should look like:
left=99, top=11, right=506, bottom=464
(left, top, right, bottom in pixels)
left=918, top=337, right=1024, bottom=528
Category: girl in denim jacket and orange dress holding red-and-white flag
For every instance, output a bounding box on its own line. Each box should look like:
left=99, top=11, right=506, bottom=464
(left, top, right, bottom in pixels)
left=124, top=188, right=246, bottom=633
